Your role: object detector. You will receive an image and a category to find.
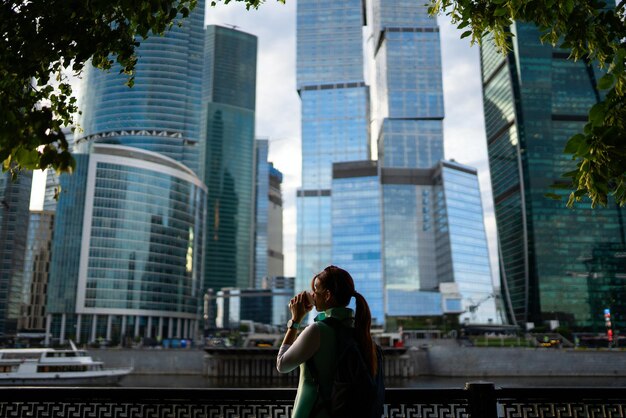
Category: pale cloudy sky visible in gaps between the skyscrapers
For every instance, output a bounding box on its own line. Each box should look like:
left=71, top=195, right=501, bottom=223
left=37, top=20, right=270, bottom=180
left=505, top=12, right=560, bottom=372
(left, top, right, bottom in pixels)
left=206, top=0, right=497, bottom=280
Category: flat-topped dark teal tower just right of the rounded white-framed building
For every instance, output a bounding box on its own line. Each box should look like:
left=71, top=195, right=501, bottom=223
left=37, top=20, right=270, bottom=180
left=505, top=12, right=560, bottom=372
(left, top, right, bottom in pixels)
left=201, top=26, right=257, bottom=289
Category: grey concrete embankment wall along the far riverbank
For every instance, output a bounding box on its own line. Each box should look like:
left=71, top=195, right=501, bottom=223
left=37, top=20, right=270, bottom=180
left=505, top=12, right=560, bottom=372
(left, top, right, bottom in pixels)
left=91, top=341, right=626, bottom=377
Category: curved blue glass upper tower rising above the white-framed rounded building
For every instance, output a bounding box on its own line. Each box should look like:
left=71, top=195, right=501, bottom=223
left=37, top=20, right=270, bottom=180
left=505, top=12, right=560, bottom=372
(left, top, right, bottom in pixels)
left=79, top=0, right=205, bottom=172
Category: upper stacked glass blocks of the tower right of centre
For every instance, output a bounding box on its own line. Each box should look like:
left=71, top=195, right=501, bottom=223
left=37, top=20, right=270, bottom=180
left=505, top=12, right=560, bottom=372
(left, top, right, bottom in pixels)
left=372, top=0, right=444, bottom=168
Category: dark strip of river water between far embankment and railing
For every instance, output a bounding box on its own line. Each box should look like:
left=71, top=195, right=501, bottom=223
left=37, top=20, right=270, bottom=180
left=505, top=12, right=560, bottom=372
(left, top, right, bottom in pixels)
left=120, top=374, right=626, bottom=389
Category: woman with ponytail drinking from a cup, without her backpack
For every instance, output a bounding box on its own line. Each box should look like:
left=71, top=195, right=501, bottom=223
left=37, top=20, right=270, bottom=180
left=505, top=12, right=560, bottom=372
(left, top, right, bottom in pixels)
left=276, top=266, right=380, bottom=418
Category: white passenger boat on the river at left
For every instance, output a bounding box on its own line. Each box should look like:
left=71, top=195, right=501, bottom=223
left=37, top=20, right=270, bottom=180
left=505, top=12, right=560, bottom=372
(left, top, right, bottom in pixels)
left=0, top=341, right=133, bottom=386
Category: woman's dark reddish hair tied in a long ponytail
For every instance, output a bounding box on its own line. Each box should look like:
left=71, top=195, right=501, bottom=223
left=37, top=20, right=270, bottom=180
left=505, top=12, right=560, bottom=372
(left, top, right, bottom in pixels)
left=311, top=266, right=378, bottom=376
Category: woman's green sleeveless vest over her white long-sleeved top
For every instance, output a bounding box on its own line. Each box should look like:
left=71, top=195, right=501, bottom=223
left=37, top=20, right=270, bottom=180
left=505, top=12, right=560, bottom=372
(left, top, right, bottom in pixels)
left=291, top=308, right=354, bottom=418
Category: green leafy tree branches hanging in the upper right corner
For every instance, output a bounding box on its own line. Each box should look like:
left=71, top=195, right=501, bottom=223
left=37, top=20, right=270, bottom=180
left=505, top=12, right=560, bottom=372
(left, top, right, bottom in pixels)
left=429, top=0, right=626, bottom=207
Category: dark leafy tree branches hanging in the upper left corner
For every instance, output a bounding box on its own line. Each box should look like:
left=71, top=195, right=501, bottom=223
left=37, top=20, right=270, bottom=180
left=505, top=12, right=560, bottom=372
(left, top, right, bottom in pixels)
left=0, top=0, right=284, bottom=177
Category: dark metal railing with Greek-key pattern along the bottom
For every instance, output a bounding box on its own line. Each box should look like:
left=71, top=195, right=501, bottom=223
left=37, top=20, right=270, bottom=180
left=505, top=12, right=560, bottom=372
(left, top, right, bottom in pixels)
left=0, top=382, right=626, bottom=418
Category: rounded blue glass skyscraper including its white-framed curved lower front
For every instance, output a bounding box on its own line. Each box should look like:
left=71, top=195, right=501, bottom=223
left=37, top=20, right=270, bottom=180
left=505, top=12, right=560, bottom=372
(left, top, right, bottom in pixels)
left=46, top=0, right=207, bottom=342
